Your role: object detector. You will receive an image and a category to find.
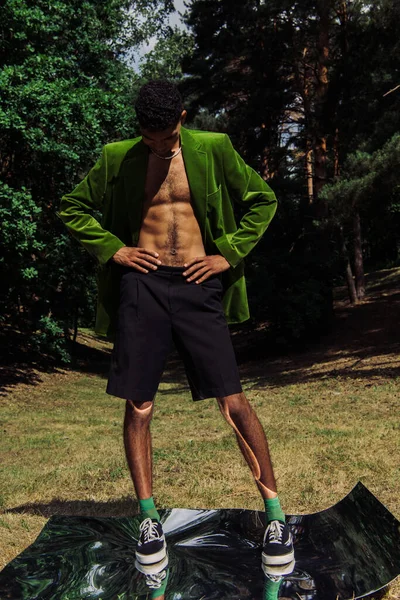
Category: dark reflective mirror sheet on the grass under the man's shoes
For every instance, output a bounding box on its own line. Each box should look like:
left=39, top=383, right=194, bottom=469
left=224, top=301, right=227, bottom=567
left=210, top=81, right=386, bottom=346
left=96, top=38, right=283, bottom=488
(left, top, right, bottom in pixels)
left=0, top=483, right=400, bottom=600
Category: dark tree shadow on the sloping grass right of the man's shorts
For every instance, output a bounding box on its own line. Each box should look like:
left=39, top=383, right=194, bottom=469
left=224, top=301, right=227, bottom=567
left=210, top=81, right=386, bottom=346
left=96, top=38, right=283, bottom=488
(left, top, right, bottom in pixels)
left=239, top=291, right=400, bottom=388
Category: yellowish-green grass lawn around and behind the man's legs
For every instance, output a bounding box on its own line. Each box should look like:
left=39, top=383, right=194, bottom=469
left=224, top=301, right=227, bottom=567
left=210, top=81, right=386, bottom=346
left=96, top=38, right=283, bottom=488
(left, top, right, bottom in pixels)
left=0, top=269, right=400, bottom=600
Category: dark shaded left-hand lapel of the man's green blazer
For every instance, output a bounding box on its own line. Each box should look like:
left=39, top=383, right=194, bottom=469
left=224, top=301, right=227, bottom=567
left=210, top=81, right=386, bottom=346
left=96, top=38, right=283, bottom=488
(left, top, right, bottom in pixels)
left=121, top=140, right=149, bottom=243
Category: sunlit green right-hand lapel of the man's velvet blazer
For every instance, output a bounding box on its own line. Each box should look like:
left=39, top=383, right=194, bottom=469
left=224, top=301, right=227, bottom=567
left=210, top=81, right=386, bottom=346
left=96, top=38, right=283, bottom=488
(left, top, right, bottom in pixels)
left=181, top=127, right=208, bottom=239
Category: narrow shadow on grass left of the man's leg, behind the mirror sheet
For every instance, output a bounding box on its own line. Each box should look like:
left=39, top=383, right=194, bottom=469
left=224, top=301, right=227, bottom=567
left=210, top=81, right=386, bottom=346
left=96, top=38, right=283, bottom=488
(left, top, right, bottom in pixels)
left=5, top=496, right=139, bottom=518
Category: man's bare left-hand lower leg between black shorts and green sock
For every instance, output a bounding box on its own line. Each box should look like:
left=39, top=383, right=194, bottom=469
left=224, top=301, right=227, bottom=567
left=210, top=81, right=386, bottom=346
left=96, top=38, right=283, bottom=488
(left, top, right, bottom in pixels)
left=124, top=400, right=153, bottom=500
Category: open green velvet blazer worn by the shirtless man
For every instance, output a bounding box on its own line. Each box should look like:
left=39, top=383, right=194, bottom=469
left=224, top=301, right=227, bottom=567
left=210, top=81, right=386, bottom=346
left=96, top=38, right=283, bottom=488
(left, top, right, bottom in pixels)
left=58, top=127, right=276, bottom=337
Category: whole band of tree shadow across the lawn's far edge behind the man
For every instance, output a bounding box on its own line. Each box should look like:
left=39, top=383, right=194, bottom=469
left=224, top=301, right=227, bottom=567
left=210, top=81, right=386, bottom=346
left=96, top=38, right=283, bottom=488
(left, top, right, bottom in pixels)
left=0, top=271, right=400, bottom=395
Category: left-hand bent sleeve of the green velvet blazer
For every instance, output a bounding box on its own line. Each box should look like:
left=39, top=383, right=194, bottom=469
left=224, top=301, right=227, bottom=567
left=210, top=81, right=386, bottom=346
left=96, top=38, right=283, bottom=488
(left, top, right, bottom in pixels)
left=58, top=146, right=125, bottom=264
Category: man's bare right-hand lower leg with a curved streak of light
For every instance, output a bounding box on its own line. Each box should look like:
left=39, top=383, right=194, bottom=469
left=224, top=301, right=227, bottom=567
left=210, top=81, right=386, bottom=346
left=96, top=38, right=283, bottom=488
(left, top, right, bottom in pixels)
left=217, top=392, right=277, bottom=498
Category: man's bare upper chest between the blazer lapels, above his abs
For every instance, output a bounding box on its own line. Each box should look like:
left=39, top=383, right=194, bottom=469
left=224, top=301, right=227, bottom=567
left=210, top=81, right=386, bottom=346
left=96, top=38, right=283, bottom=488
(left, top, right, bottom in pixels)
left=145, top=154, right=190, bottom=205
